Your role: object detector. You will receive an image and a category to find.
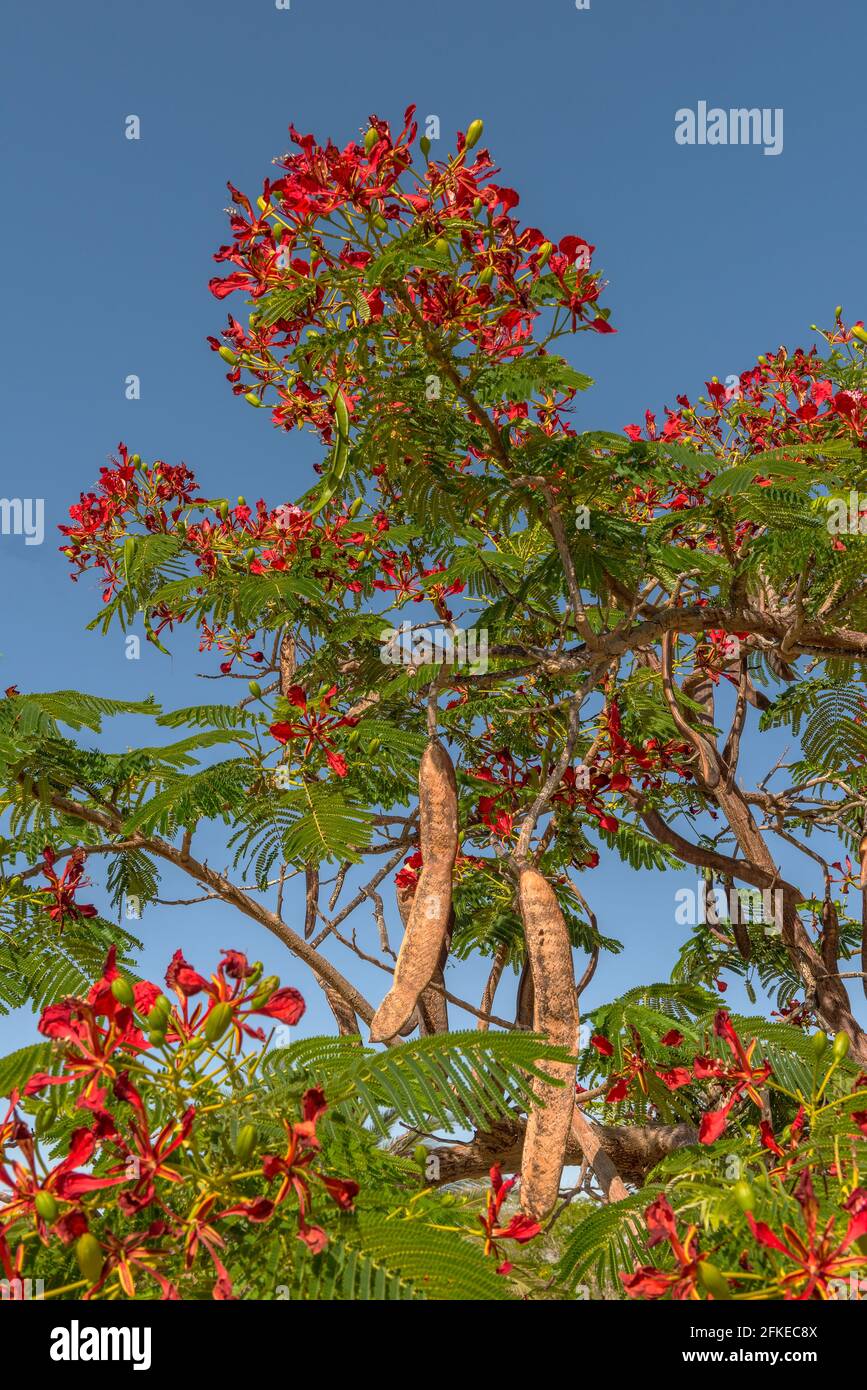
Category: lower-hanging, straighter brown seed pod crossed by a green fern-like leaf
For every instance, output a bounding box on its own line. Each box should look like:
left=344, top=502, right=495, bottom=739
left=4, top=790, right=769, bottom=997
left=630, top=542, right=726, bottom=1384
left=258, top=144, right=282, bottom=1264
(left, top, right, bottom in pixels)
left=518, top=869, right=578, bottom=1220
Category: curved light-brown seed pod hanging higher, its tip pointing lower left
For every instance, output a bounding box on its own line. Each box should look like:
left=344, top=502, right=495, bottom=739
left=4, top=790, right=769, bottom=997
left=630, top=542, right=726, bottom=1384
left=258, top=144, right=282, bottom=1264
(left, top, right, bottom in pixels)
left=371, top=738, right=457, bottom=1043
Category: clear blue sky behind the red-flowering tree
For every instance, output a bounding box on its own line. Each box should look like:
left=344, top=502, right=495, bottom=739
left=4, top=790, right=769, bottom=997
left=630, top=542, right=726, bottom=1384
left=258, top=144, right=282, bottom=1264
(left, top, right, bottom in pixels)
left=0, top=0, right=867, bottom=1049
